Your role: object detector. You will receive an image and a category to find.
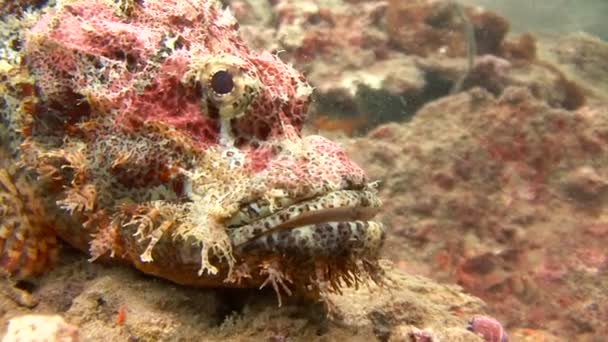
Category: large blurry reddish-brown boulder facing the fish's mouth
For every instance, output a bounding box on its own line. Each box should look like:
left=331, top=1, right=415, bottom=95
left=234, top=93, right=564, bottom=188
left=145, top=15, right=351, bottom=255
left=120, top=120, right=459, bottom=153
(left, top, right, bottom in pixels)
left=348, top=88, right=608, bottom=340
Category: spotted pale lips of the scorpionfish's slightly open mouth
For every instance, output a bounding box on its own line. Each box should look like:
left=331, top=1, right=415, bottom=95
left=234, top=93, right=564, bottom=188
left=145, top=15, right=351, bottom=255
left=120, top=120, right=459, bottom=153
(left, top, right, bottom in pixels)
left=226, top=186, right=385, bottom=258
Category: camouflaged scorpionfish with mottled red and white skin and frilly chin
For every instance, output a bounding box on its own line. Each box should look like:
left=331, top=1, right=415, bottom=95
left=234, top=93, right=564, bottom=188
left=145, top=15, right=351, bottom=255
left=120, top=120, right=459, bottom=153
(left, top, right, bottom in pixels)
left=0, top=0, right=385, bottom=302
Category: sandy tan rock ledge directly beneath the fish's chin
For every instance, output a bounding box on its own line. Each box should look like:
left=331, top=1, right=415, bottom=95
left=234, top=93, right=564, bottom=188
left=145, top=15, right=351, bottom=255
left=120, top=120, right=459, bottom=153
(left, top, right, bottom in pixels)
left=0, top=252, right=484, bottom=341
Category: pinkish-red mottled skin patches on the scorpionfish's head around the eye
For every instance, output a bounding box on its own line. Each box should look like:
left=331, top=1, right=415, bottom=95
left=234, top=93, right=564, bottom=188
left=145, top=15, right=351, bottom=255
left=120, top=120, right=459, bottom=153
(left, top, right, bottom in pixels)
left=27, top=0, right=365, bottom=183
